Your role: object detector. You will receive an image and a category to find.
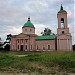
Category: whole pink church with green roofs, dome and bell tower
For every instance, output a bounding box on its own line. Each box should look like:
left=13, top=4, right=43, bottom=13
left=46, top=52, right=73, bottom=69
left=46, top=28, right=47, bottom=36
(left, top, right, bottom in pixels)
left=10, top=5, right=72, bottom=51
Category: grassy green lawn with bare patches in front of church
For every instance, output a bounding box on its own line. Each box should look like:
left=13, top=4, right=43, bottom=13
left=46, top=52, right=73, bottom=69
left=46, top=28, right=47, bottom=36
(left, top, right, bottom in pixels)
left=0, top=52, right=75, bottom=75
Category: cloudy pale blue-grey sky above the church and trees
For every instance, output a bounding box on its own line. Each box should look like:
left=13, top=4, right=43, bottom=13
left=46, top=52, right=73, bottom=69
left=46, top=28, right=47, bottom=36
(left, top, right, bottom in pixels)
left=0, top=0, right=75, bottom=44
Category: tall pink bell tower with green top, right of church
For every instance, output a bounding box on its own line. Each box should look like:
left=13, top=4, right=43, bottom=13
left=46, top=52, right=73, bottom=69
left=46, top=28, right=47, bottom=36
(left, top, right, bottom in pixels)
left=57, top=5, right=72, bottom=51
